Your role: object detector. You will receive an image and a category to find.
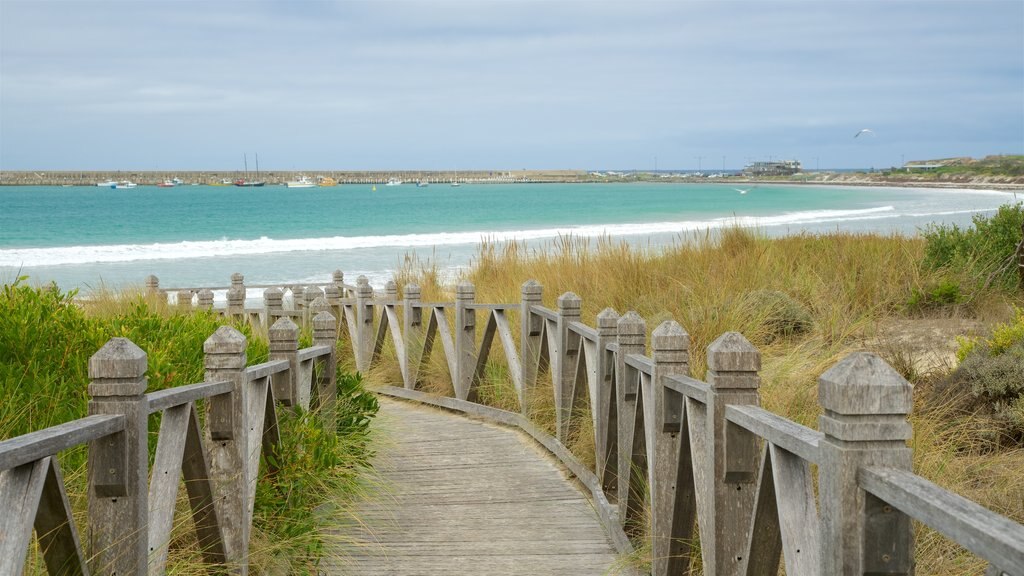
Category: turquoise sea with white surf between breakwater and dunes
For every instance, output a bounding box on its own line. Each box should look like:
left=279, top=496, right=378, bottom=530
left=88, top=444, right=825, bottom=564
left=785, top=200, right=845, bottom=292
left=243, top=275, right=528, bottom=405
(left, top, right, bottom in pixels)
left=0, top=183, right=1024, bottom=291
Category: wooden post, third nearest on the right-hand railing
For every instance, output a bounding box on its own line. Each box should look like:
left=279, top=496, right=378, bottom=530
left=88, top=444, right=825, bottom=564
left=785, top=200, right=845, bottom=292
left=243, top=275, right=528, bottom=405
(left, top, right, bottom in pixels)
left=642, top=320, right=692, bottom=576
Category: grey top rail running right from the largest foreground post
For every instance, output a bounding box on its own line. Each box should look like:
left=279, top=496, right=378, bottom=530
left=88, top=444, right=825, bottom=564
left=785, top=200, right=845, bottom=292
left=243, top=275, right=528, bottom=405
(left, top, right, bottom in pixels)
left=857, top=467, right=1024, bottom=575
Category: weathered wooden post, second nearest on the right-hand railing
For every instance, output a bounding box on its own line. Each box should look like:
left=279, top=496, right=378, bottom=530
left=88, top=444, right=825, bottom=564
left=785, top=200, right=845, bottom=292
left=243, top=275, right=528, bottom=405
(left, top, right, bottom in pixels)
left=692, top=332, right=761, bottom=576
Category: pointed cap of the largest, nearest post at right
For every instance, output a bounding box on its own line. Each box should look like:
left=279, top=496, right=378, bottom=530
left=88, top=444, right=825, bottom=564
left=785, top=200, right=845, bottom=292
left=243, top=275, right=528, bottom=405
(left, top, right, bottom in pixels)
left=818, top=352, right=913, bottom=415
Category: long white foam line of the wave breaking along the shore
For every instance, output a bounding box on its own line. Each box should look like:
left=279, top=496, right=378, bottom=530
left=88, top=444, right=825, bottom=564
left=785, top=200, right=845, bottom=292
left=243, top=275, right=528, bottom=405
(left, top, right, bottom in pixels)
left=0, top=206, right=987, bottom=268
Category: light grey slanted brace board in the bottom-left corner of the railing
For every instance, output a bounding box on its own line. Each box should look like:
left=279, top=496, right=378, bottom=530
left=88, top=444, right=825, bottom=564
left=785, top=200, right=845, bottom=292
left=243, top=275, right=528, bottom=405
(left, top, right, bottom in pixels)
left=0, top=456, right=50, bottom=576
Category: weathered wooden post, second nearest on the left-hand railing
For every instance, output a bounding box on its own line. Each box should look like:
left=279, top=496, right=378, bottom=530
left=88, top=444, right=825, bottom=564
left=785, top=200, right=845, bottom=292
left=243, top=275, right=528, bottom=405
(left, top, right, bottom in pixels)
left=203, top=326, right=252, bottom=574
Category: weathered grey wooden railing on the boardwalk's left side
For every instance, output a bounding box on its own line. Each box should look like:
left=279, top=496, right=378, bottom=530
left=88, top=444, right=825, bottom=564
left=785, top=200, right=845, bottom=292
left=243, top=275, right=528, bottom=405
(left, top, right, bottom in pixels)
left=0, top=312, right=337, bottom=576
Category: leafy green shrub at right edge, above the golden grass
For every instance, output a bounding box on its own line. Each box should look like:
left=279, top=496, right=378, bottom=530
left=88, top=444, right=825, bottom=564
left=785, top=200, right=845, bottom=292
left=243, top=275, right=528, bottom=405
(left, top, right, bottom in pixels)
left=923, top=203, right=1024, bottom=290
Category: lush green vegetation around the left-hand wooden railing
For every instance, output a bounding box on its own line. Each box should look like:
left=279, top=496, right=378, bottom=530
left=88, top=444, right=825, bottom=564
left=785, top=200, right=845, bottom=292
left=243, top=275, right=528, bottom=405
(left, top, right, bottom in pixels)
left=0, top=280, right=377, bottom=574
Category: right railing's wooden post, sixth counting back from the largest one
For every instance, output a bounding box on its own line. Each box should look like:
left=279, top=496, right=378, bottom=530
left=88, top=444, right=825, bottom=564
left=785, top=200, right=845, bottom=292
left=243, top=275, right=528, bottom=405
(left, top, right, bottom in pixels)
left=551, top=292, right=583, bottom=442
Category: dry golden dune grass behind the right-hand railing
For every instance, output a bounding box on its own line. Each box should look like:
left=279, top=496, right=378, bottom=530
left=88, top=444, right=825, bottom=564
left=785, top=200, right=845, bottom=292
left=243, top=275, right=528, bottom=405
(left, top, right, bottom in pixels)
left=378, top=229, right=1024, bottom=574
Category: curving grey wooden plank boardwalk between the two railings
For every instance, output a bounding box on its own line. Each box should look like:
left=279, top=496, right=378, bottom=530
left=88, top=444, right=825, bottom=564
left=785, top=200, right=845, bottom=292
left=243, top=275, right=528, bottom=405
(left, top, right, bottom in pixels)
left=330, top=399, right=616, bottom=576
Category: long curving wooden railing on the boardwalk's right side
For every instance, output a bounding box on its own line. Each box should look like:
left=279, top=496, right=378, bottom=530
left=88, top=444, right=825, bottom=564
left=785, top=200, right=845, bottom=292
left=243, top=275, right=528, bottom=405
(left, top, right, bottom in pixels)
left=172, top=273, right=1024, bottom=576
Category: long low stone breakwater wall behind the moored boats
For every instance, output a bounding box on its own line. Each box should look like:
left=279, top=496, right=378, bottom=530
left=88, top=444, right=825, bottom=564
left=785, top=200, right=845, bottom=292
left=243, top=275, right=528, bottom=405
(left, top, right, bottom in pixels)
left=0, top=170, right=587, bottom=186
